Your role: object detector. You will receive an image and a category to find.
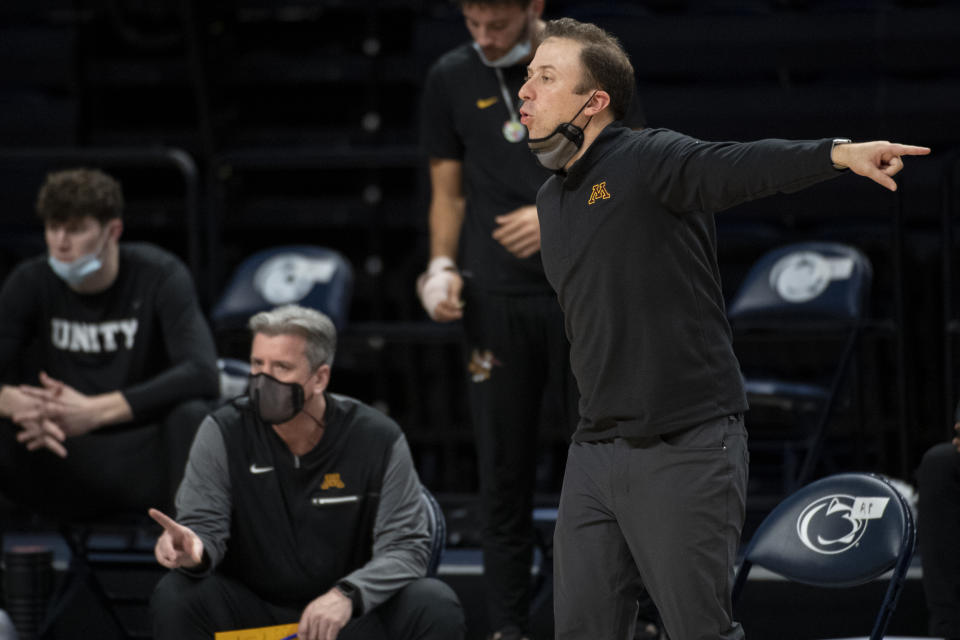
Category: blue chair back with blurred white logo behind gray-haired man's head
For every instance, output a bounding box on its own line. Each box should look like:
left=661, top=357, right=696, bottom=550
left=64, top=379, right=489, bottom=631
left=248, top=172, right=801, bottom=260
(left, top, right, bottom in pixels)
left=210, top=245, right=353, bottom=331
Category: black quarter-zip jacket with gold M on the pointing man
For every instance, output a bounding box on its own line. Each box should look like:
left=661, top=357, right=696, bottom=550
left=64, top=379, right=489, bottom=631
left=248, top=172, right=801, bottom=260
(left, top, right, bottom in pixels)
left=537, top=123, right=842, bottom=442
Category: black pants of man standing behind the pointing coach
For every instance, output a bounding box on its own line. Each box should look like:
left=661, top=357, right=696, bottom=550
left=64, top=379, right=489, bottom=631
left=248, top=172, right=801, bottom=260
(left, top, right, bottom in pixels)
left=464, top=288, right=578, bottom=631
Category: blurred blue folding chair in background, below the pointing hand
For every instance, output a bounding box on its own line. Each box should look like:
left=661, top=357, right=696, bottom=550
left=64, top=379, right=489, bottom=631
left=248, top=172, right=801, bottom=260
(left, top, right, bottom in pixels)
left=727, top=242, right=873, bottom=498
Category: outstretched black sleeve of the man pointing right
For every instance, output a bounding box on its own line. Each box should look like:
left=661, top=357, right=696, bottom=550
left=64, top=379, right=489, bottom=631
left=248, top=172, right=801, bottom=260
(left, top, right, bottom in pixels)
left=637, top=130, right=843, bottom=213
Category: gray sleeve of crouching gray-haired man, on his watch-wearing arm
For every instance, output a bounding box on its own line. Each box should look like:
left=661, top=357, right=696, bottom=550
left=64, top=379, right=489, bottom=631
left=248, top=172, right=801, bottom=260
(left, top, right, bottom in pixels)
left=344, top=436, right=430, bottom=613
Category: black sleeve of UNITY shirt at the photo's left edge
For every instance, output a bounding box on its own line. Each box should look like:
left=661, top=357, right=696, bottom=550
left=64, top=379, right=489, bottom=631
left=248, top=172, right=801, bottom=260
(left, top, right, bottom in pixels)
left=0, top=264, right=39, bottom=384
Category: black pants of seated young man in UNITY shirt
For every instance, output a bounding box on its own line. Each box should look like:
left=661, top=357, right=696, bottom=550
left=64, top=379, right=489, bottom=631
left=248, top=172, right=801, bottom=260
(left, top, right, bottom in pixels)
left=0, top=400, right=213, bottom=518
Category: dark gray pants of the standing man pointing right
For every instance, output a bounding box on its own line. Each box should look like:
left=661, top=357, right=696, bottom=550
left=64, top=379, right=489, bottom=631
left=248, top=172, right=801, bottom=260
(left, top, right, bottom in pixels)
left=554, top=415, right=749, bottom=640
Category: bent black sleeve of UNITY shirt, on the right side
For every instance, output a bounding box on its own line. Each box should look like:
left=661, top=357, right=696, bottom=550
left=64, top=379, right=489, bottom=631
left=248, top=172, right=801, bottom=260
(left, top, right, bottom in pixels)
left=123, top=262, right=219, bottom=417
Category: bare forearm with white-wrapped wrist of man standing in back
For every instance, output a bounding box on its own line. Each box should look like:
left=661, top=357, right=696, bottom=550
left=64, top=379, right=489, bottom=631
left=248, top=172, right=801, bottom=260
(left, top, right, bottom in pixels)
left=417, top=158, right=466, bottom=322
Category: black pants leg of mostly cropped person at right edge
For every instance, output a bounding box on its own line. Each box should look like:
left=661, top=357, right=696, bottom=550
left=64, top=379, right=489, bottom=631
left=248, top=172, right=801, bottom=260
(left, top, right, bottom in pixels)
left=917, top=442, right=960, bottom=638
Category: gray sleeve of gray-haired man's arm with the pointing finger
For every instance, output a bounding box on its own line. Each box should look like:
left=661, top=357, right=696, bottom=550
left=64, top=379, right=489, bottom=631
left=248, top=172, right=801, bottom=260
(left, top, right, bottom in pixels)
left=176, top=416, right=232, bottom=575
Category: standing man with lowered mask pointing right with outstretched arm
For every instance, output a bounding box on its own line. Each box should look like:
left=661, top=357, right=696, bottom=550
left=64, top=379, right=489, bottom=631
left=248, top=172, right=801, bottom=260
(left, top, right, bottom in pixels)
left=519, top=19, right=929, bottom=640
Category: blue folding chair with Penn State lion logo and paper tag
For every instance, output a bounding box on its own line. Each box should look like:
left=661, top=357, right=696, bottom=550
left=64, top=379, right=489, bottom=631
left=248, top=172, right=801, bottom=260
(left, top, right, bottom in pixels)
left=733, top=473, right=916, bottom=640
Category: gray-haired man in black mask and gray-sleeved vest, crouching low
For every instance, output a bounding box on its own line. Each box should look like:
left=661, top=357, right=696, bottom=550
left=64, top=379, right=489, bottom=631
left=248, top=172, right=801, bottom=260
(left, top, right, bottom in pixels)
left=150, top=305, right=465, bottom=640
